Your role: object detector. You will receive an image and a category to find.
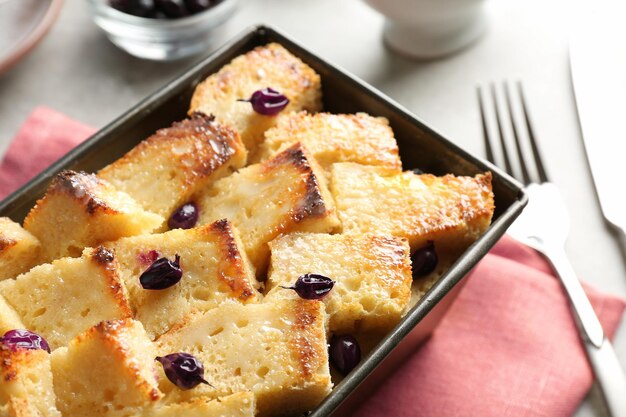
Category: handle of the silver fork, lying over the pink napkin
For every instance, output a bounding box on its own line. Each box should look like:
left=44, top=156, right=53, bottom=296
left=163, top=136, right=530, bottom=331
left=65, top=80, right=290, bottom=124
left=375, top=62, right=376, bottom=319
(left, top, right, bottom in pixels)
left=537, top=247, right=626, bottom=417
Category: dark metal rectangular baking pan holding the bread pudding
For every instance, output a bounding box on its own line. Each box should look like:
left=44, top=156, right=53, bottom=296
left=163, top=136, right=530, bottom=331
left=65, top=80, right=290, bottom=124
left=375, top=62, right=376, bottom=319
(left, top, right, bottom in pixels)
left=0, top=26, right=527, bottom=417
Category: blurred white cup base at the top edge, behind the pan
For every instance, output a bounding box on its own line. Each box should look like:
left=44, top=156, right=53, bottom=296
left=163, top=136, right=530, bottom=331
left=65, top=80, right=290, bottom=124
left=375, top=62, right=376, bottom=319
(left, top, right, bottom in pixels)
left=363, top=0, right=486, bottom=59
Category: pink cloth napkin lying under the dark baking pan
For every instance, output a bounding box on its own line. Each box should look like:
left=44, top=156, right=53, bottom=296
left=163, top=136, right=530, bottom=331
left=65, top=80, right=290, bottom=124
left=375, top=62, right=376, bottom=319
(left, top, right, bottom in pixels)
left=0, top=108, right=625, bottom=417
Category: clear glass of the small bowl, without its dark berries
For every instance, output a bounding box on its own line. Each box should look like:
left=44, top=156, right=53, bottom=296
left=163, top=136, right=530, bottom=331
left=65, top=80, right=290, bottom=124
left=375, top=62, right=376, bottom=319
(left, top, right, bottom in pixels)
left=89, top=0, right=238, bottom=61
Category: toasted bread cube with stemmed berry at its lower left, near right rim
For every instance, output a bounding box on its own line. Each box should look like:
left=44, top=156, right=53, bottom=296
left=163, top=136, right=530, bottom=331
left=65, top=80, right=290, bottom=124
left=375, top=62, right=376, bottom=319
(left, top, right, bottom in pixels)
left=266, top=233, right=412, bottom=333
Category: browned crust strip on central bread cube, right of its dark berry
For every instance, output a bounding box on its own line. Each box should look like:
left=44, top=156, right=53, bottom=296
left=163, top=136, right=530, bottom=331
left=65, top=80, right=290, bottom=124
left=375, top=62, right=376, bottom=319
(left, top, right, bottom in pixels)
left=207, top=219, right=256, bottom=301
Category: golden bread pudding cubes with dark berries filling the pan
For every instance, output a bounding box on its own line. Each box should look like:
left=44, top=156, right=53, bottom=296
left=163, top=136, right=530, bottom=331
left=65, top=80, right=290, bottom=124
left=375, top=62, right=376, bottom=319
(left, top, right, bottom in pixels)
left=0, top=43, right=494, bottom=417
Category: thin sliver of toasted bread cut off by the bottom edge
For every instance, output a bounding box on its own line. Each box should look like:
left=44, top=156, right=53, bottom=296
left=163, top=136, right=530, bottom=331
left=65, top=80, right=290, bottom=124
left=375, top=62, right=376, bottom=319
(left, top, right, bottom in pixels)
left=144, top=392, right=256, bottom=417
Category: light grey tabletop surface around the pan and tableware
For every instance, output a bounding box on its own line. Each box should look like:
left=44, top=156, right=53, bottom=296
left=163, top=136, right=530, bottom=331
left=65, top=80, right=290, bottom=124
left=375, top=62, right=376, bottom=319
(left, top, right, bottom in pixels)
left=0, top=0, right=626, bottom=417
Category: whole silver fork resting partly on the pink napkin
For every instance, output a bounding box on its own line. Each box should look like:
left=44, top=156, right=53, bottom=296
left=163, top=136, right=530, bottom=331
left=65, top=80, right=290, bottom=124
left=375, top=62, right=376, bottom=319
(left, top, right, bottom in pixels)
left=477, top=82, right=626, bottom=417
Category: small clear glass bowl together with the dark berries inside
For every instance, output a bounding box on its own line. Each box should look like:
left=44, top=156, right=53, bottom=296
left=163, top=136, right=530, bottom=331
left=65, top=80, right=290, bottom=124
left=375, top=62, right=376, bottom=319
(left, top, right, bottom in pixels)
left=89, top=0, right=237, bottom=61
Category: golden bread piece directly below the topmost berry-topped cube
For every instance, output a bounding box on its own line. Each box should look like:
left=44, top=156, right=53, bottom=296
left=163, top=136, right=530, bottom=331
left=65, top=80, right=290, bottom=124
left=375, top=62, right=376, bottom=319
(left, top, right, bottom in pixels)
left=257, top=112, right=402, bottom=172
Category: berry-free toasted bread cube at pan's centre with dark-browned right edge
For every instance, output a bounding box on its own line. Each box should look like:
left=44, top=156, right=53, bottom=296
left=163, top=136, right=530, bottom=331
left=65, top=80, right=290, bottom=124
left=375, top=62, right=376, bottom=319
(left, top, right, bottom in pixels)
left=198, top=143, right=338, bottom=276
